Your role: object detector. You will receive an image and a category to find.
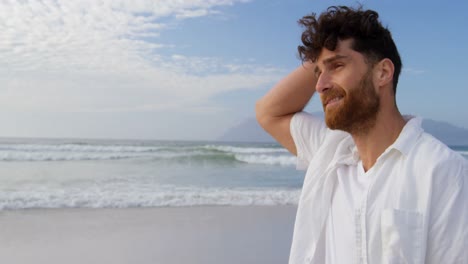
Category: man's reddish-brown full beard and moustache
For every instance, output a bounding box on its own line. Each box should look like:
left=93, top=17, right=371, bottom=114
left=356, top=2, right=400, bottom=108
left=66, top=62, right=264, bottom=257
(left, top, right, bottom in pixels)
left=322, top=70, right=380, bottom=135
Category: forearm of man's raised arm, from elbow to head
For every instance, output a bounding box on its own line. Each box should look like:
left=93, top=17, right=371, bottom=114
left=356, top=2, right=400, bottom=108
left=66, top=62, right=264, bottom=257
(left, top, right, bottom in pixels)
left=256, top=62, right=317, bottom=121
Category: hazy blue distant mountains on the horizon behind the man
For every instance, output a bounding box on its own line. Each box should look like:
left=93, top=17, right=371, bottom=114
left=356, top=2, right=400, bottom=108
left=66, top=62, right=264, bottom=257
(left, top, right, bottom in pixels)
left=219, top=113, right=468, bottom=146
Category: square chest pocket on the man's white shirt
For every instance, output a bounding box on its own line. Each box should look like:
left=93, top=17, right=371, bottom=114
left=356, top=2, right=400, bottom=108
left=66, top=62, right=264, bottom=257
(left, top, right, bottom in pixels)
left=380, top=209, right=424, bottom=264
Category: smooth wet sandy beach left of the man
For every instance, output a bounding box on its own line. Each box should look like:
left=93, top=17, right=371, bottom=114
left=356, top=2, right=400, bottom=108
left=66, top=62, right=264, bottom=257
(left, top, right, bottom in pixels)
left=0, top=206, right=296, bottom=264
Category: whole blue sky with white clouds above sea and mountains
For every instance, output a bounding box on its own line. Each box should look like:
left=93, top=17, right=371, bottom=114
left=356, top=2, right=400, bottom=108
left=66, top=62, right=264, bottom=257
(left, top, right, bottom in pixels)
left=0, top=0, right=468, bottom=140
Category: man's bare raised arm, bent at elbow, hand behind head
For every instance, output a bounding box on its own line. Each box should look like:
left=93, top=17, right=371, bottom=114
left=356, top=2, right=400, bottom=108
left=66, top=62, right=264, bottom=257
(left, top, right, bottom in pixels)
left=255, top=62, right=317, bottom=155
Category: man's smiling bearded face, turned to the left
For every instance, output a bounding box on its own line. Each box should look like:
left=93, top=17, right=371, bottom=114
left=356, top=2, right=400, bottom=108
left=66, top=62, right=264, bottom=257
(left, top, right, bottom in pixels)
left=316, top=41, right=380, bottom=134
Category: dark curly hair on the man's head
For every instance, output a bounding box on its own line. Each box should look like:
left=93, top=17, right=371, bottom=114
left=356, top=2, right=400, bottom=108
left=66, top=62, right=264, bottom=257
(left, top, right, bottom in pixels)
left=297, top=6, right=402, bottom=93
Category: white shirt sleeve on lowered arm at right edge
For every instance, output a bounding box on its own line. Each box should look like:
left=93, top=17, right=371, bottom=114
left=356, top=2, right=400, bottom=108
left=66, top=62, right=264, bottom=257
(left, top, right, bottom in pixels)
left=426, top=158, right=468, bottom=264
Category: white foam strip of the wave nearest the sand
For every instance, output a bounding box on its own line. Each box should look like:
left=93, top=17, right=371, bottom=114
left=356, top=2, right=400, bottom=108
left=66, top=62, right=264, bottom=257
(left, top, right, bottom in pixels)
left=0, top=186, right=300, bottom=210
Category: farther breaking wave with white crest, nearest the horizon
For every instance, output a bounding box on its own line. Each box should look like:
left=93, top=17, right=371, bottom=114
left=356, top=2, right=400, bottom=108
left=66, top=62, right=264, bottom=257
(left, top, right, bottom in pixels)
left=0, top=144, right=295, bottom=166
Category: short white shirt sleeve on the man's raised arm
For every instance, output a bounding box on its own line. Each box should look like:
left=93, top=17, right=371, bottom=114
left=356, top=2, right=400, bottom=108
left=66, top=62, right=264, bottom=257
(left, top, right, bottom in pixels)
left=290, top=112, right=327, bottom=170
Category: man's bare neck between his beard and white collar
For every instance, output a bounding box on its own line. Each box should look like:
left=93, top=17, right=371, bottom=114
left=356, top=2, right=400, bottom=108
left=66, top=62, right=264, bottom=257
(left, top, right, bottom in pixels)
left=352, top=111, right=406, bottom=171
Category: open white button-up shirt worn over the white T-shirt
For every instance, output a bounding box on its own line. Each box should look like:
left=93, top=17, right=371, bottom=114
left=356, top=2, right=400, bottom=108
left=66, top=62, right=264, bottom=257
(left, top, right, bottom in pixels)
left=289, top=112, right=468, bottom=264
